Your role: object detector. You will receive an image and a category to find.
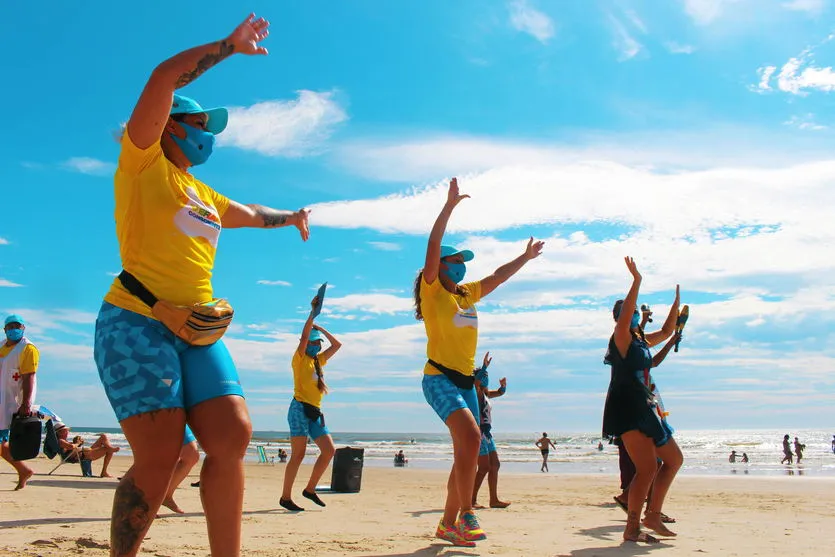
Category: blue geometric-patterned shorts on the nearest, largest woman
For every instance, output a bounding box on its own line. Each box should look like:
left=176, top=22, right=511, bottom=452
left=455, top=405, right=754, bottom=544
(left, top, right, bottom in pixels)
left=93, top=302, right=244, bottom=421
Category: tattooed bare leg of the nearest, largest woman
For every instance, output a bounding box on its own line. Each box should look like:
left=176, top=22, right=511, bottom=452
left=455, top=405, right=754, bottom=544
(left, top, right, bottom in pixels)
left=110, top=408, right=186, bottom=557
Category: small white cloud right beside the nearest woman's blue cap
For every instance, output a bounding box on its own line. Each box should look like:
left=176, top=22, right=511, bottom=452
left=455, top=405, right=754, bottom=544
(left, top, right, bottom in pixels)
left=218, top=90, right=348, bottom=157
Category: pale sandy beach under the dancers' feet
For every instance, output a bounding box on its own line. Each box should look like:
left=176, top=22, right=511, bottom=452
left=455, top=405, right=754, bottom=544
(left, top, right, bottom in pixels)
left=0, top=457, right=835, bottom=557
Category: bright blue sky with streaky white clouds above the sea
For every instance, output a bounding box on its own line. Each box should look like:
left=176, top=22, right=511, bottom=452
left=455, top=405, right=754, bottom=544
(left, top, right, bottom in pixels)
left=0, top=0, right=835, bottom=432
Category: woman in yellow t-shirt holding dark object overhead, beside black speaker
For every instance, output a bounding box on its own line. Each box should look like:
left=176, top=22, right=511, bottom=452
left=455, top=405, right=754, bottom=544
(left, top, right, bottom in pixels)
left=279, top=296, right=342, bottom=511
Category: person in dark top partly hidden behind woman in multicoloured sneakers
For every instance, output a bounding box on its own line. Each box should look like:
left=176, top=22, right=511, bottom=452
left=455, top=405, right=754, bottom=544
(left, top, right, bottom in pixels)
left=473, top=352, right=510, bottom=509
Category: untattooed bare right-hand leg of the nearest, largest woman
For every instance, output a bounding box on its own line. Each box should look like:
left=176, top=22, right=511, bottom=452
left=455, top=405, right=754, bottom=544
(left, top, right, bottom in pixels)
left=189, top=395, right=252, bottom=557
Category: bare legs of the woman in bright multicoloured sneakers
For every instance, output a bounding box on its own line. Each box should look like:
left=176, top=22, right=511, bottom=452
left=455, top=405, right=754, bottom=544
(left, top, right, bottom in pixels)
left=443, top=408, right=481, bottom=527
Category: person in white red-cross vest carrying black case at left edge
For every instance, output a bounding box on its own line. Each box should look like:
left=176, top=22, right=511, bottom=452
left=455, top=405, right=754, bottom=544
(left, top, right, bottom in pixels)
left=0, top=314, right=40, bottom=490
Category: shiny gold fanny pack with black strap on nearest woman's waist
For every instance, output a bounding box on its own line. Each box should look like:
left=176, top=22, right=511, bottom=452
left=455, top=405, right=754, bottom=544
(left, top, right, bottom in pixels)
left=119, top=270, right=235, bottom=346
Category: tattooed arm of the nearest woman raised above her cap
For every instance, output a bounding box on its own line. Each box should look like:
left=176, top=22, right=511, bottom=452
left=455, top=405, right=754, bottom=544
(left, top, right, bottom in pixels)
left=128, top=14, right=270, bottom=149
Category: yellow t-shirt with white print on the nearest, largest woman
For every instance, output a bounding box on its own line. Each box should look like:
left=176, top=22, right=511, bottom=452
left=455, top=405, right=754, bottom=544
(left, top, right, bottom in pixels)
left=104, top=131, right=235, bottom=317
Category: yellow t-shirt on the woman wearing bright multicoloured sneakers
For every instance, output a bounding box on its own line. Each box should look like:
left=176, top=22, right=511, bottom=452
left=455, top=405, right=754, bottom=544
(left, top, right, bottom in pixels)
left=420, top=277, right=481, bottom=375
